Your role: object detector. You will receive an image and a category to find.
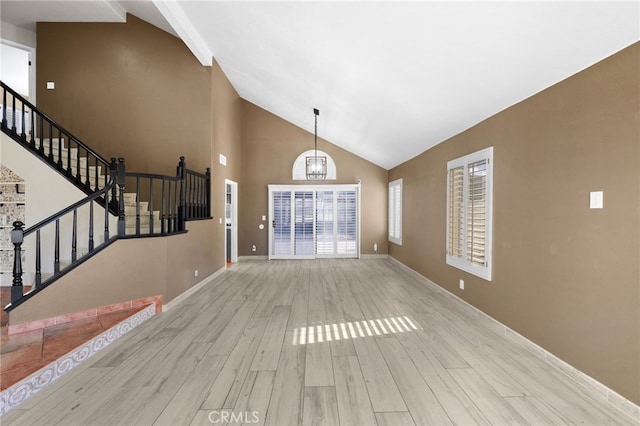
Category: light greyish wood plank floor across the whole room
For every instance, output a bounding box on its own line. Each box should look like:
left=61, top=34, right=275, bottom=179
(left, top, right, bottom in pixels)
left=1, top=258, right=635, bottom=425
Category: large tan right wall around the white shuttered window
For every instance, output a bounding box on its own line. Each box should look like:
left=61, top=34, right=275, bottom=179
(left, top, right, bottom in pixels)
left=389, top=44, right=640, bottom=403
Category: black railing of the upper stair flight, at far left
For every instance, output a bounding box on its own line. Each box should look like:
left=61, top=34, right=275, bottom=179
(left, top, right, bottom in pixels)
left=0, top=81, right=109, bottom=194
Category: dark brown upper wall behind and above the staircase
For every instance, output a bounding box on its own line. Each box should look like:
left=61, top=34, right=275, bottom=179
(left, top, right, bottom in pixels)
left=36, top=15, right=212, bottom=175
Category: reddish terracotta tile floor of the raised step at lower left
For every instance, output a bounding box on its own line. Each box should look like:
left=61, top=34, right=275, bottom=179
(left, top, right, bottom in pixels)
left=0, top=301, right=144, bottom=391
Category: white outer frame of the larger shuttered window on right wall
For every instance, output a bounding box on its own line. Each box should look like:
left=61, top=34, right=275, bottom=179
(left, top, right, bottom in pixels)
left=446, top=147, right=493, bottom=281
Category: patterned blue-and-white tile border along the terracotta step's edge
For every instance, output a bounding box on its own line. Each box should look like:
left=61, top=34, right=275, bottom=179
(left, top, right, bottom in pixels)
left=0, top=304, right=157, bottom=416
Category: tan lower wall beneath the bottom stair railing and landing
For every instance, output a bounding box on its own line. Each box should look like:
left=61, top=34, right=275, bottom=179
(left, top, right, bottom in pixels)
left=9, top=221, right=219, bottom=325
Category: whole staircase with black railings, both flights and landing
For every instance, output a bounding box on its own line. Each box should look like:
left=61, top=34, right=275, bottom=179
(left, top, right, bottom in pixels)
left=0, top=82, right=211, bottom=312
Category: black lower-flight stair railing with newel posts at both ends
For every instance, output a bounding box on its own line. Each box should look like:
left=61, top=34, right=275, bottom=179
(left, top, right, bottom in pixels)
left=6, top=158, right=124, bottom=311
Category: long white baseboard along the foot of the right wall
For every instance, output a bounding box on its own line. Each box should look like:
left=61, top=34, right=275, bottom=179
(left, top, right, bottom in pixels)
left=389, top=256, right=640, bottom=424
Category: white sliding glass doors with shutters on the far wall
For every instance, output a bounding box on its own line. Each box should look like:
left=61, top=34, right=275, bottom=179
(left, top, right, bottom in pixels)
left=269, top=185, right=360, bottom=259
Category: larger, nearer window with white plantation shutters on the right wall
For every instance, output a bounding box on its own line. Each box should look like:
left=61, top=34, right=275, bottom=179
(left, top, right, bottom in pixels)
left=447, top=147, right=493, bottom=281
